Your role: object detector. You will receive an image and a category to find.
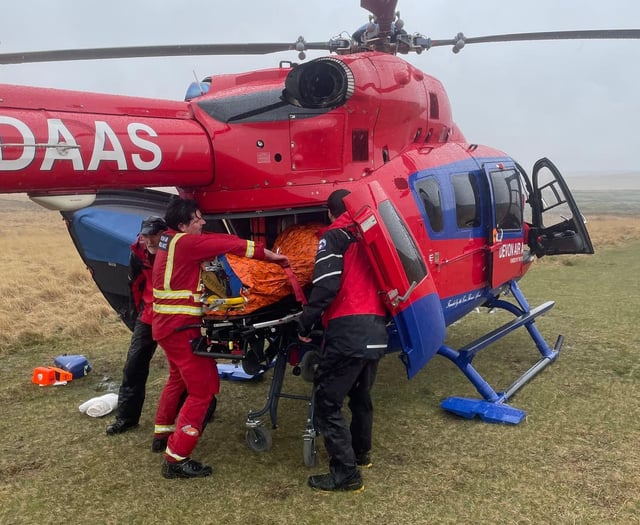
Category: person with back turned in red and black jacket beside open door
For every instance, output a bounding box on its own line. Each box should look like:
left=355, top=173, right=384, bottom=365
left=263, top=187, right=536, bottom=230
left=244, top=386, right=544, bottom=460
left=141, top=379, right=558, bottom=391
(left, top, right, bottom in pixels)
left=298, top=190, right=388, bottom=492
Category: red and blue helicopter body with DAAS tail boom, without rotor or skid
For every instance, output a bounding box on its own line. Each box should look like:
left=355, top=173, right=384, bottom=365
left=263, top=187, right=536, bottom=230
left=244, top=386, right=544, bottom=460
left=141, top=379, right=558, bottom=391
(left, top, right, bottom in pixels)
left=0, top=52, right=592, bottom=388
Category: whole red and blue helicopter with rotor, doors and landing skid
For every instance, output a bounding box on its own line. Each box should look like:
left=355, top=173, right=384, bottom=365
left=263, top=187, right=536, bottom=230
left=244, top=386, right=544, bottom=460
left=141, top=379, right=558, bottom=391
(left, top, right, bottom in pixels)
left=0, top=0, right=640, bottom=452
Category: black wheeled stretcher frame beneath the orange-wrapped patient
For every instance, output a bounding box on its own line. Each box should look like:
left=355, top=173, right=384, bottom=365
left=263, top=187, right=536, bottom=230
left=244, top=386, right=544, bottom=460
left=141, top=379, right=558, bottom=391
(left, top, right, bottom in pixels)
left=193, top=296, right=321, bottom=467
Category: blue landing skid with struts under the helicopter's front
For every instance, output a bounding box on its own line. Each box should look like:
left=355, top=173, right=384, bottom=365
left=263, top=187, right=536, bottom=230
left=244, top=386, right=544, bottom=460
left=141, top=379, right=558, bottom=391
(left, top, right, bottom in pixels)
left=438, top=281, right=564, bottom=425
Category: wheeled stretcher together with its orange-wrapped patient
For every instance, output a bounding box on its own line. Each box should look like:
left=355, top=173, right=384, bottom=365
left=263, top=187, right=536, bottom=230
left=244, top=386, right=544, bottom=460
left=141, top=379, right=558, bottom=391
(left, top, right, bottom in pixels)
left=188, top=224, right=321, bottom=466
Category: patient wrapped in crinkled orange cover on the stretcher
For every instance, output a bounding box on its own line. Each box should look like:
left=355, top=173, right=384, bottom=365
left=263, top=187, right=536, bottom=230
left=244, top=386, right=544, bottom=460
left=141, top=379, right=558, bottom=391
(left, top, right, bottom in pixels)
left=201, top=223, right=324, bottom=318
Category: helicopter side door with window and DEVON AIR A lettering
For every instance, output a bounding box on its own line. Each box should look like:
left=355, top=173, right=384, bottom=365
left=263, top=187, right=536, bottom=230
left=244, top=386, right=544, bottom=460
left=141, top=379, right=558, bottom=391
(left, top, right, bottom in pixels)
left=483, top=162, right=526, bottom=287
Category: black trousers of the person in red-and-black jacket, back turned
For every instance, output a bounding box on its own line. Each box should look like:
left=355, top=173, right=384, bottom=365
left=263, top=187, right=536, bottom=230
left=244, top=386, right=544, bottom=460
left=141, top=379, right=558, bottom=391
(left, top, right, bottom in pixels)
left=314, top=353, right=379, bottom=483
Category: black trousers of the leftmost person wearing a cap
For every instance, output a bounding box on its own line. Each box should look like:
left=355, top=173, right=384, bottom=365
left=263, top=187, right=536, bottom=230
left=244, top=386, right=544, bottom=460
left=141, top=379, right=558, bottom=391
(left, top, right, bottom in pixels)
left=116, top=317, right=158, bottom=424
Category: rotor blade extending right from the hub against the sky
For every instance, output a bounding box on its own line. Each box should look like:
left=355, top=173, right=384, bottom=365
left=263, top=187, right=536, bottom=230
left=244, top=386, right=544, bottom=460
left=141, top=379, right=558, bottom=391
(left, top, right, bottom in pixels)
left=431, top=29, right=640, bottom=49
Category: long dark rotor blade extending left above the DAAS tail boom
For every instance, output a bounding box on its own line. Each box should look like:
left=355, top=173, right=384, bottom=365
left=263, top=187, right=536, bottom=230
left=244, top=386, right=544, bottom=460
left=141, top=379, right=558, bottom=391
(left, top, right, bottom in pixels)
left=0, top=41, right=331, bottom=64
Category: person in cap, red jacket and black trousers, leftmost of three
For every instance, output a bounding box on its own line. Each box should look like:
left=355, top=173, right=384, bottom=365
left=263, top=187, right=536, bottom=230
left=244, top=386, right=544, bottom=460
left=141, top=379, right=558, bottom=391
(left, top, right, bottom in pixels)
left=107, top=216, right=167, bottom=436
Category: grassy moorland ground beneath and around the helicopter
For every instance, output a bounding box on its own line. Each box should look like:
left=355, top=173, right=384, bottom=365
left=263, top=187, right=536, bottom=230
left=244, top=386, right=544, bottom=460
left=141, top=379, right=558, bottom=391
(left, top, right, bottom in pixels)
left=0, top=192, right=640, bottom=525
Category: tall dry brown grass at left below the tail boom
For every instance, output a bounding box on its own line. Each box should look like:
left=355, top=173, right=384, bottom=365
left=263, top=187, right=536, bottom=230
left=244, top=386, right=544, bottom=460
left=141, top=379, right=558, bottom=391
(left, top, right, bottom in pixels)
left=0, top=196, right=124, bottom=355
